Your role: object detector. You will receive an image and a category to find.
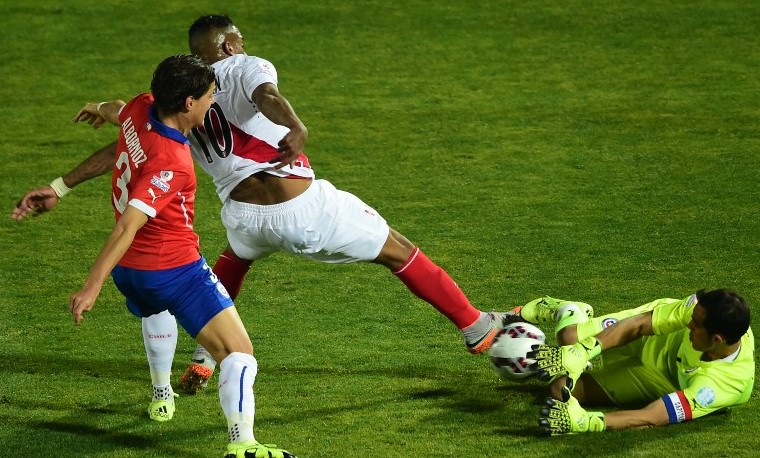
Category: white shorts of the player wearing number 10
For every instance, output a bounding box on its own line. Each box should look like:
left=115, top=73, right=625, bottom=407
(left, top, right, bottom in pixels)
left=222, top=180, right=390, bottom=263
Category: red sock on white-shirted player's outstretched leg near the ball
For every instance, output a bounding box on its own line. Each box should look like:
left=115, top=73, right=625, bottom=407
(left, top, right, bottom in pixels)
left=393, top=248, right=480, bottom=329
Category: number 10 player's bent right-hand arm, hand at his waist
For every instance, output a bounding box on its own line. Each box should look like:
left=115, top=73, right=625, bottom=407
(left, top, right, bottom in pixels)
left=251, top=83, right=309, bottom=169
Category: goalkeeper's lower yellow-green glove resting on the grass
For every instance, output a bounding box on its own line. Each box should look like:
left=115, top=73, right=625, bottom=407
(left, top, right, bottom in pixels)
left=538, top=380, right=606, bottom=436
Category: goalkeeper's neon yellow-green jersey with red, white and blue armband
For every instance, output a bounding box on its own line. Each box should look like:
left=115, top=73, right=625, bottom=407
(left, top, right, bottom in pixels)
left=639, top=295, right=755, bottom=423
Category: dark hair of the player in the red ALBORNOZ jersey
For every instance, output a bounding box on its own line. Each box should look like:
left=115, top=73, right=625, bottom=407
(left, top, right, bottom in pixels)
left=150, top=54, right=215, bottom=115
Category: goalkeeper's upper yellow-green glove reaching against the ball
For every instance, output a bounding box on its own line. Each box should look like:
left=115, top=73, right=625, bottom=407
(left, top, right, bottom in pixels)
left=527, top=337, right=602, bottom=382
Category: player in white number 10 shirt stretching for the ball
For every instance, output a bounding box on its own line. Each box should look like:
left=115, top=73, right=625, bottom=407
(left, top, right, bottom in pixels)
left=14, top=15, right=503, bottom=392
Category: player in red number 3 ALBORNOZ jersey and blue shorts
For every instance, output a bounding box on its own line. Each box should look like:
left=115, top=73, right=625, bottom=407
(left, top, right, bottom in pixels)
left=69, top=56, right=293, bottom=458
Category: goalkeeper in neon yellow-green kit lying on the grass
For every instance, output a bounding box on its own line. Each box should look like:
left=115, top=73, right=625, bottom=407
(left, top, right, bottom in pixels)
left=510, top=289, right=755, bottom=435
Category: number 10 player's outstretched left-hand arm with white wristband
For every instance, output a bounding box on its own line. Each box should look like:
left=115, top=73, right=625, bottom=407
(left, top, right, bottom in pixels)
left=11, top=142, right=116, bottom=221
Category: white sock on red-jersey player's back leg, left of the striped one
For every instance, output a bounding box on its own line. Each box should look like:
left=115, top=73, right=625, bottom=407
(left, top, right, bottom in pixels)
left=142, top=311, right=177, bottom=389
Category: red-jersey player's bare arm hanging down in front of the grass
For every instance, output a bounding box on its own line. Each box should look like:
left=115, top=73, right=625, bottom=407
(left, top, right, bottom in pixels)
left=69, top=205, right=148, bottom=325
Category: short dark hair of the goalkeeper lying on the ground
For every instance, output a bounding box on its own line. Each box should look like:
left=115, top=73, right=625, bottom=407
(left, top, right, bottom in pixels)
left=697, top=289, right=750, bottom=345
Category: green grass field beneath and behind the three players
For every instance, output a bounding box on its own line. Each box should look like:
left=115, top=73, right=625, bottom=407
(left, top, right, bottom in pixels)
left=0, top=0, right=760, bottom=458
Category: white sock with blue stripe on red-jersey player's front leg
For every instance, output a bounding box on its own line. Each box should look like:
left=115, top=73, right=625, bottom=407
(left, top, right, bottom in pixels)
left=219, top=352, right=258, bottom=442
